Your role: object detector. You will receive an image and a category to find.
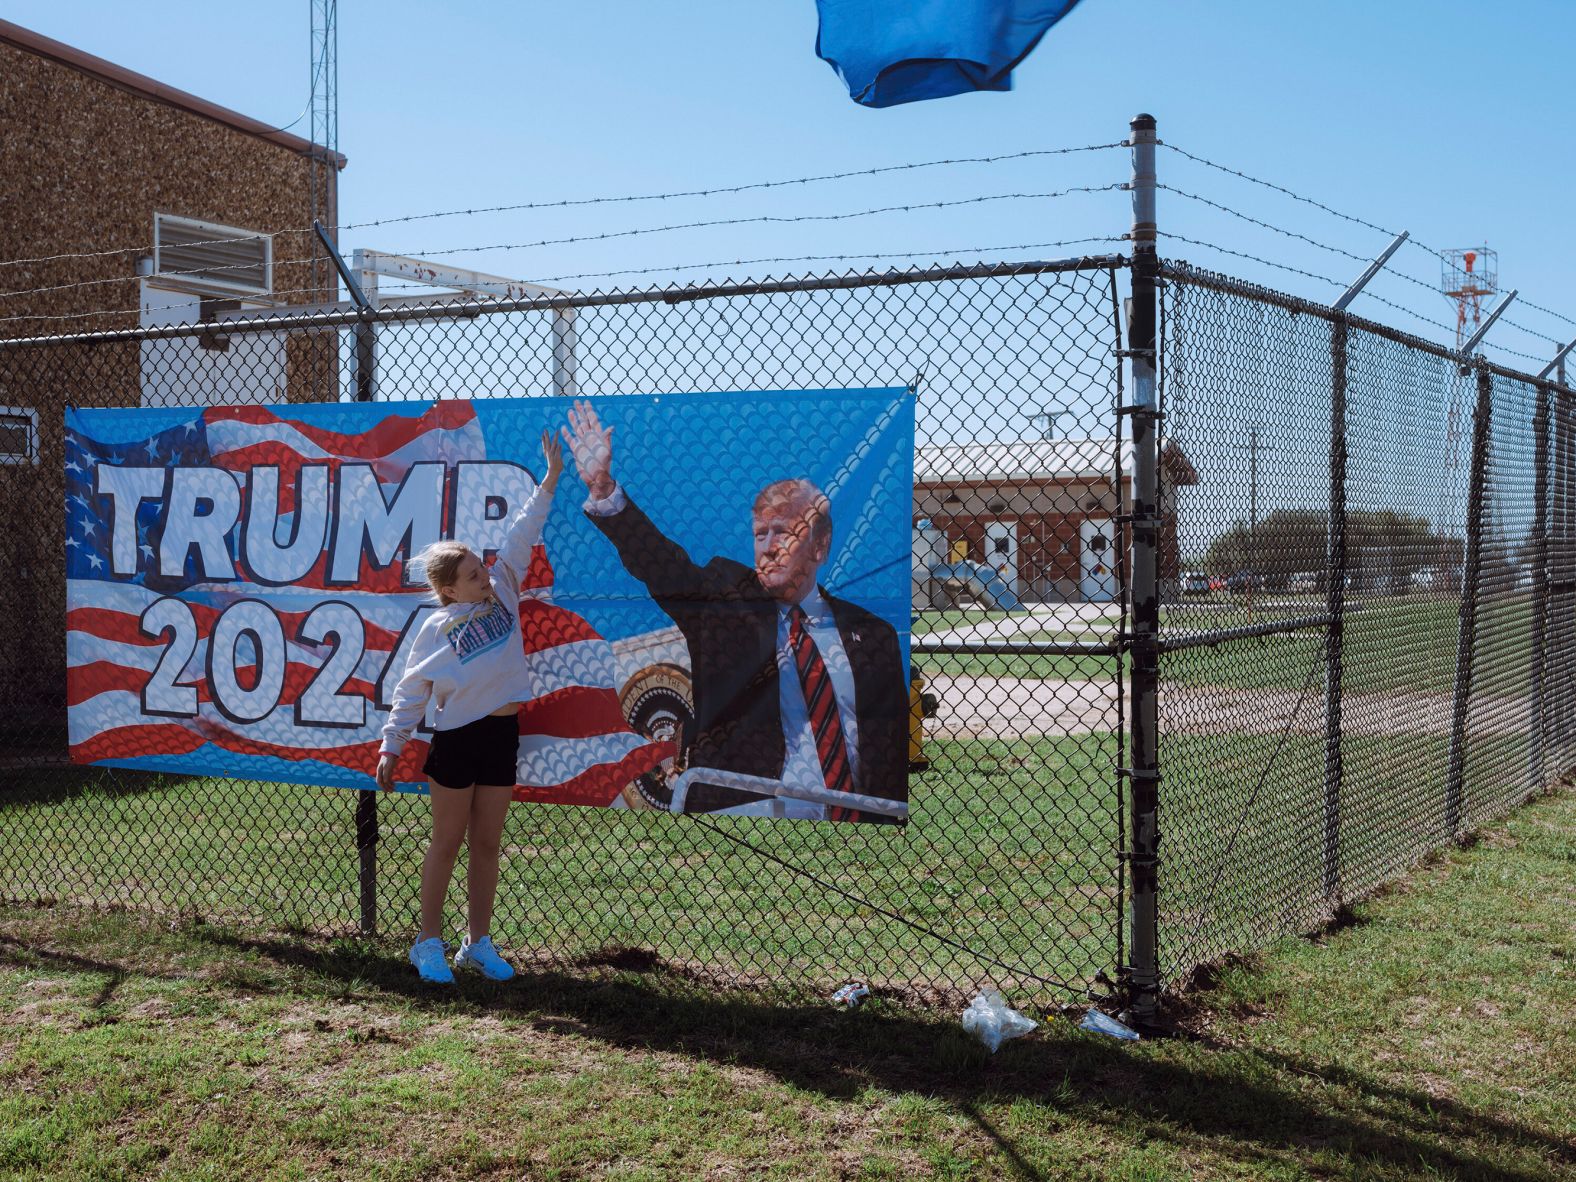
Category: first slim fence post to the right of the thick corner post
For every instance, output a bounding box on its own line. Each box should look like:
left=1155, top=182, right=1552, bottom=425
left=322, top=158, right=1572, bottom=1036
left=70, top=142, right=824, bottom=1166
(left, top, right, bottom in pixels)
left=1324, top=314, right=1349, bottom=913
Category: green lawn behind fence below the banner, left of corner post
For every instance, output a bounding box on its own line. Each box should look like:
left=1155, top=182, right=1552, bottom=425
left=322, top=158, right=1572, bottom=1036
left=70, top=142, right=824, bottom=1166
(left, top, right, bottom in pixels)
left=0, top=734, right=1121, bottom=993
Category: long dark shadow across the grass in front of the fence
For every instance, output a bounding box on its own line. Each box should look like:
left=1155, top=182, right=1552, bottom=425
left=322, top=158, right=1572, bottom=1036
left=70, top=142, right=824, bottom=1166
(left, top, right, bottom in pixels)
left=12, top=924, right=1557, bottom=1182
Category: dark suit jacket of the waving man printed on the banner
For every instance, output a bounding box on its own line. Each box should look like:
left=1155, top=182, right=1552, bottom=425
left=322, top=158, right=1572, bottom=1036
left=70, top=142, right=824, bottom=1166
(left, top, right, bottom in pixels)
left=588, top=501, right=908, bottom=821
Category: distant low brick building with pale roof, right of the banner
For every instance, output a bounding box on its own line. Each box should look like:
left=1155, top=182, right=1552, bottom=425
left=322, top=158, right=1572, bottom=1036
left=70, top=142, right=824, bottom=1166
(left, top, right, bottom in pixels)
left=914, top=438, right=1198, bottom=602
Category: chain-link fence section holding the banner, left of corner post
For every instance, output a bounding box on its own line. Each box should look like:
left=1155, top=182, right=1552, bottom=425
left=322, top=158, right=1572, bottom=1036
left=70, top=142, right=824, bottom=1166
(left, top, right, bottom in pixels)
left=0, top=258, right=1130, bottom=996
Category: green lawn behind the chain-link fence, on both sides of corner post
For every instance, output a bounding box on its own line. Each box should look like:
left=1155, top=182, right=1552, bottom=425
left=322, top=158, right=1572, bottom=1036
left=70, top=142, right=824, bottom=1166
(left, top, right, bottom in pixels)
left=0, top=712, right=1535, bottom=1021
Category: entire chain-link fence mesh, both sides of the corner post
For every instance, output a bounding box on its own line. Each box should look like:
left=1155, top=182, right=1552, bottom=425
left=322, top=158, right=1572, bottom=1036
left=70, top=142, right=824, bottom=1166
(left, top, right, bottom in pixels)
left=0, top=245, right=1576, bottom=998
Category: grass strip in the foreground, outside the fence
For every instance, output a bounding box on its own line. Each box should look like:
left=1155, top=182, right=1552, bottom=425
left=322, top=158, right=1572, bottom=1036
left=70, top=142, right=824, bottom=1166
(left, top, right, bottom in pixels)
left=0, top=791, right=1576, bottom=1182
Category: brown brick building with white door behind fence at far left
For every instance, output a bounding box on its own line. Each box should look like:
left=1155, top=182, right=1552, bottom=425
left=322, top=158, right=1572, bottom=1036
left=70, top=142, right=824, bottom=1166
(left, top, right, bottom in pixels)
left=0, top=20, right=345, bottom=737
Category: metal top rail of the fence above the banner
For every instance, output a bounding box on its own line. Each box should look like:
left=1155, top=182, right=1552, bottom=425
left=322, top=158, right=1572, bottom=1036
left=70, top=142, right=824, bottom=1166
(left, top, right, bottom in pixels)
left=0, top=254, right=1127, bottom=350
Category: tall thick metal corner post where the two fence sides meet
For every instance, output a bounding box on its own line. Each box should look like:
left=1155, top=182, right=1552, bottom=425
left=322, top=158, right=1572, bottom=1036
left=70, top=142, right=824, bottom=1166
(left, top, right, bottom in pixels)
left=1124, top=115, right=1160, bottom=1023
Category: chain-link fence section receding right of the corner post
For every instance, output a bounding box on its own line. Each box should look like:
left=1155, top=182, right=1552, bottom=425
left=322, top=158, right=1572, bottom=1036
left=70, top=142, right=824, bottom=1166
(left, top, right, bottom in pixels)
left=1160, top=265, right=1576, bottom=982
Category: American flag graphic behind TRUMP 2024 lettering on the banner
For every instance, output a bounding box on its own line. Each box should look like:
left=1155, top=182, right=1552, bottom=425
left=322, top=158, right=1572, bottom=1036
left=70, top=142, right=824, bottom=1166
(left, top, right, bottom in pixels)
left=65, top=402, right=673, bottom=805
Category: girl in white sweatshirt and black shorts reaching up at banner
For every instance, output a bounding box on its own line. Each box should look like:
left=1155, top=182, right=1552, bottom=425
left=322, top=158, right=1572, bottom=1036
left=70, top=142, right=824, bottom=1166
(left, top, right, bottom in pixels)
left=377, top=432, right=564, bottom=983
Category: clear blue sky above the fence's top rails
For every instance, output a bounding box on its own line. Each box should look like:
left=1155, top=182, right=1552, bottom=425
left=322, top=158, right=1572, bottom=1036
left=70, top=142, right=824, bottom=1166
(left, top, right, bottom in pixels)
left=6, top=0, right=1576, bottom=364
